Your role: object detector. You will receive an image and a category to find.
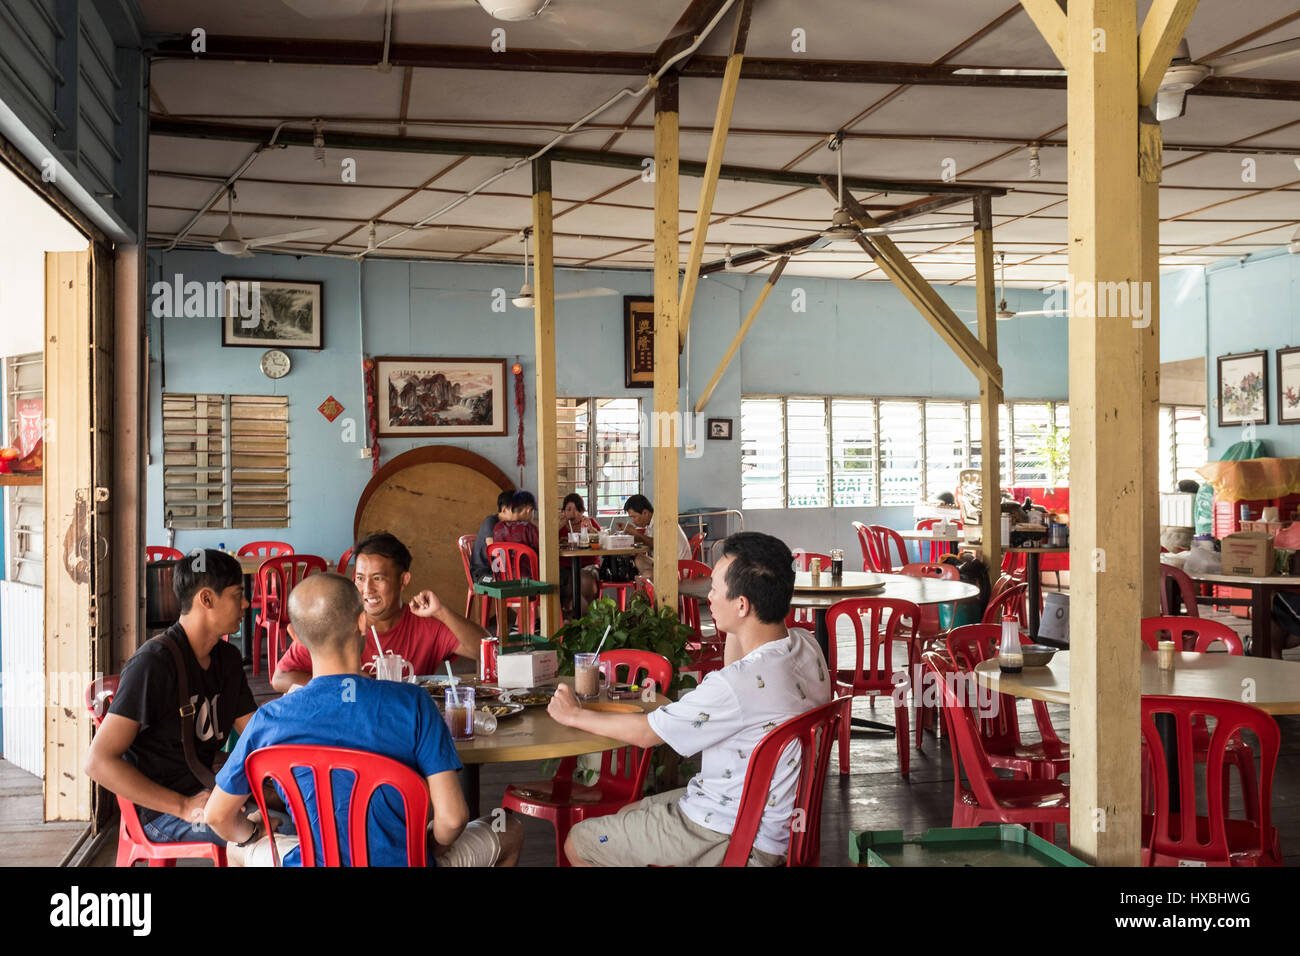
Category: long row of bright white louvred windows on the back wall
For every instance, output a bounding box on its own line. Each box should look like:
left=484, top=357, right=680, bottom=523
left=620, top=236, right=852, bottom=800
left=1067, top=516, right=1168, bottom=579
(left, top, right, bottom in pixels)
left=740, top=395, right=1208, bottom=509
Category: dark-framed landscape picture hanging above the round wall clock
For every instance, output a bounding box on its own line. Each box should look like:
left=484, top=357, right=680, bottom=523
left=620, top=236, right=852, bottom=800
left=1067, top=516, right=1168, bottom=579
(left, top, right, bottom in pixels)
left=221, top=277, right=325, bottom=349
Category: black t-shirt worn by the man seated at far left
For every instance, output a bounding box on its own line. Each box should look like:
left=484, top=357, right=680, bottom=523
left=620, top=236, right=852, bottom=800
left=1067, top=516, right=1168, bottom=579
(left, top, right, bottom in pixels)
left=108, top=624, right=257, bottom=822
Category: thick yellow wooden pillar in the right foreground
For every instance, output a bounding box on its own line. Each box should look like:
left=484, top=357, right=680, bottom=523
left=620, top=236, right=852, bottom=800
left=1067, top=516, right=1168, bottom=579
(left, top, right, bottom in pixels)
left=1066, top=0, right=1143, bottom=866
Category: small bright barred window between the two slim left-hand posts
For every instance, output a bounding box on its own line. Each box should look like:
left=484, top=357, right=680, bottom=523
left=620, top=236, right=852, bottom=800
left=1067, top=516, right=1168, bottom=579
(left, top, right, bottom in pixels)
left=555, top=398, right=641, bottom=515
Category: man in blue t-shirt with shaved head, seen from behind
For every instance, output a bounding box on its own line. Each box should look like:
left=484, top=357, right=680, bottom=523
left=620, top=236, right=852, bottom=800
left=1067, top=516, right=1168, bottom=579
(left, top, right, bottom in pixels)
left=207, top=574, right=523, bottom=866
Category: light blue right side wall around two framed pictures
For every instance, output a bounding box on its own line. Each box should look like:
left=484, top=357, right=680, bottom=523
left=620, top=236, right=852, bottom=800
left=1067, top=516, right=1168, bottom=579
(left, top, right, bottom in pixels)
left=1205, top=251, right=1300, bottom=459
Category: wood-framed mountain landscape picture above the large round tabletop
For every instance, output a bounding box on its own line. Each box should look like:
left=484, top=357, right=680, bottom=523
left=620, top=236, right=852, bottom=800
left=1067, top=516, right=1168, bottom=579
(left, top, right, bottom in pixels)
left=374, top=355, right=507, bottom=438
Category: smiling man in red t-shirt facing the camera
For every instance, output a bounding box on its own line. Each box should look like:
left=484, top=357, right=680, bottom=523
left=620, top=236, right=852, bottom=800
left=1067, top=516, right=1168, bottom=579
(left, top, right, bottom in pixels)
left=270, top=532, right=488, bottom=693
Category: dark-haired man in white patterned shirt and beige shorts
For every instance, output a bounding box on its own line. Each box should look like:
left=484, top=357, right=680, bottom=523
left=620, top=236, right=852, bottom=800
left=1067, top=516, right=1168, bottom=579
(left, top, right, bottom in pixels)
left=550, top=532, right=831, bottom=866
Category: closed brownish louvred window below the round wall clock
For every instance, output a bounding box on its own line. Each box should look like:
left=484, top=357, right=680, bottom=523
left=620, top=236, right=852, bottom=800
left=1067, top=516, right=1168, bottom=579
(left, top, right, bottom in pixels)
left=163, top=393, right=289, bottom=528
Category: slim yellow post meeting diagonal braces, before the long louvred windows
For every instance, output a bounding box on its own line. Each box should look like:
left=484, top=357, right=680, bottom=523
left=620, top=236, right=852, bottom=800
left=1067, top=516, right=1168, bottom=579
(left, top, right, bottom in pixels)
left=975, top=196, right=1002, bottom=567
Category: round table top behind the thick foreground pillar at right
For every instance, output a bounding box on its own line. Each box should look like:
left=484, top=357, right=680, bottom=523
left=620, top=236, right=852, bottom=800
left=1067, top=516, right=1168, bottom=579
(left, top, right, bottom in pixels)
left=975, top=649, right=1300, bottom=714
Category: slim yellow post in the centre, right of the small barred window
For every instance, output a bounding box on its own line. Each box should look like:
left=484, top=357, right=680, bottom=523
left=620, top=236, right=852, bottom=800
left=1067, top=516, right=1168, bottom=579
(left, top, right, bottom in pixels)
left=650, top=73, right=683, bottom=609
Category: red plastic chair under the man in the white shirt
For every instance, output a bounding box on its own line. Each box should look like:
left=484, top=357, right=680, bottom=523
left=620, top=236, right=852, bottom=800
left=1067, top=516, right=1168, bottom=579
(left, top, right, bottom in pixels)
left=722, top=697, right=853, bottom=866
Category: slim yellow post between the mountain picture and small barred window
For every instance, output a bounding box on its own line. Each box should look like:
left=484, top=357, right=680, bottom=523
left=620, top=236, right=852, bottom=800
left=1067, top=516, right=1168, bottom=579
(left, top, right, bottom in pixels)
left=533, top=156, right=560, bottom=637
